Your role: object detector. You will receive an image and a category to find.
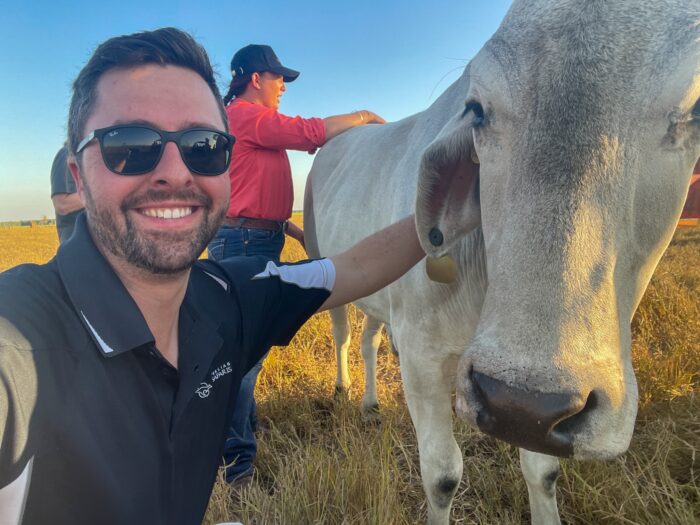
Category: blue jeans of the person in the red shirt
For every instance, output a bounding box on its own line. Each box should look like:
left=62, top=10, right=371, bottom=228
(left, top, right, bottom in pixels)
left=207, top=226, right=284, bottom=482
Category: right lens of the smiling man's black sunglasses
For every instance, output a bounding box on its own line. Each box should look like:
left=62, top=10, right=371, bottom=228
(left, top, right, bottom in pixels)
left=180, top=129, right=231, bottom=175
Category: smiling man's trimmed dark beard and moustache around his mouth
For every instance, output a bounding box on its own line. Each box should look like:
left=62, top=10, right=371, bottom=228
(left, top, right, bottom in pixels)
left=85, top=185, right=226, bottom=274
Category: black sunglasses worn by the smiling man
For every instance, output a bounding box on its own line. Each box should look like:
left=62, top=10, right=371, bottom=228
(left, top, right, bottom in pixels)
left=75, top=124, right=236, bottom=176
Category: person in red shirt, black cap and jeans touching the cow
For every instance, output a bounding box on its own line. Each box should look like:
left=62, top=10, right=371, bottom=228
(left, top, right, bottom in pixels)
left=208, top=44, right=384, bottom=483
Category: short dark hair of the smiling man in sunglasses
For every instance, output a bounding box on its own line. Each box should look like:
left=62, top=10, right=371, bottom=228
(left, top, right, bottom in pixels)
left=68, top=27, right=228, bottom=154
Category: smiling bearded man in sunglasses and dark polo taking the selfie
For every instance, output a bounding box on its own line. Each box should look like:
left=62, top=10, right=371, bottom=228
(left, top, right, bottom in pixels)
left=0, top=28, right=423, bottom=525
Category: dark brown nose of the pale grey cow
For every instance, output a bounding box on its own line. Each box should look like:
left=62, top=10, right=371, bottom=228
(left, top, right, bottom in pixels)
left=471, top=371, right=596, bottom=456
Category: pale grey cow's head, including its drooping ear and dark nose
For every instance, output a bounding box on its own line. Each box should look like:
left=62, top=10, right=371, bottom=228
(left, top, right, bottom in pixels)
left=417, top=0, right=700, bottom=458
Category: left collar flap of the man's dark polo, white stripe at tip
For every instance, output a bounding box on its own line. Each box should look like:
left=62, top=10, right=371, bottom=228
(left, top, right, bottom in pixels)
left=56, top=213, right=155, bottom=357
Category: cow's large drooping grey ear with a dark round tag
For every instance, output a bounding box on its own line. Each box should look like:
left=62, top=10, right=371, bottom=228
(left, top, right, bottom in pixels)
left=416, top=122, right=481, bottom=256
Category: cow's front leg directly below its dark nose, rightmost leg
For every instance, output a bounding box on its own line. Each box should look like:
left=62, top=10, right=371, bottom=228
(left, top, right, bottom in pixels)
left=520, top=448, right=561, bottom=525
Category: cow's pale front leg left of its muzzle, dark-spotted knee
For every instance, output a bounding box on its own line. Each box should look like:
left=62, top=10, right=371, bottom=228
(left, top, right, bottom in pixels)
left=397, top=344, right=462, bottom=525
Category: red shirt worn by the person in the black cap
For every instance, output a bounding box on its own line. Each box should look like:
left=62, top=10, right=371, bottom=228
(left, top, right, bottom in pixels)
left=226, top=99, right=326, bottom=221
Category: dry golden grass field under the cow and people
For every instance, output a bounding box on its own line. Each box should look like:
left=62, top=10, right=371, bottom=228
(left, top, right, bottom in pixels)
left=0, top=216, right=700, bottom=525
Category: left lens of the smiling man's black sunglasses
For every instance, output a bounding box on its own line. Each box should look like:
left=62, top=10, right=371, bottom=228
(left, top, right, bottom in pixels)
left=102, top=127, right=163, bottom=175
